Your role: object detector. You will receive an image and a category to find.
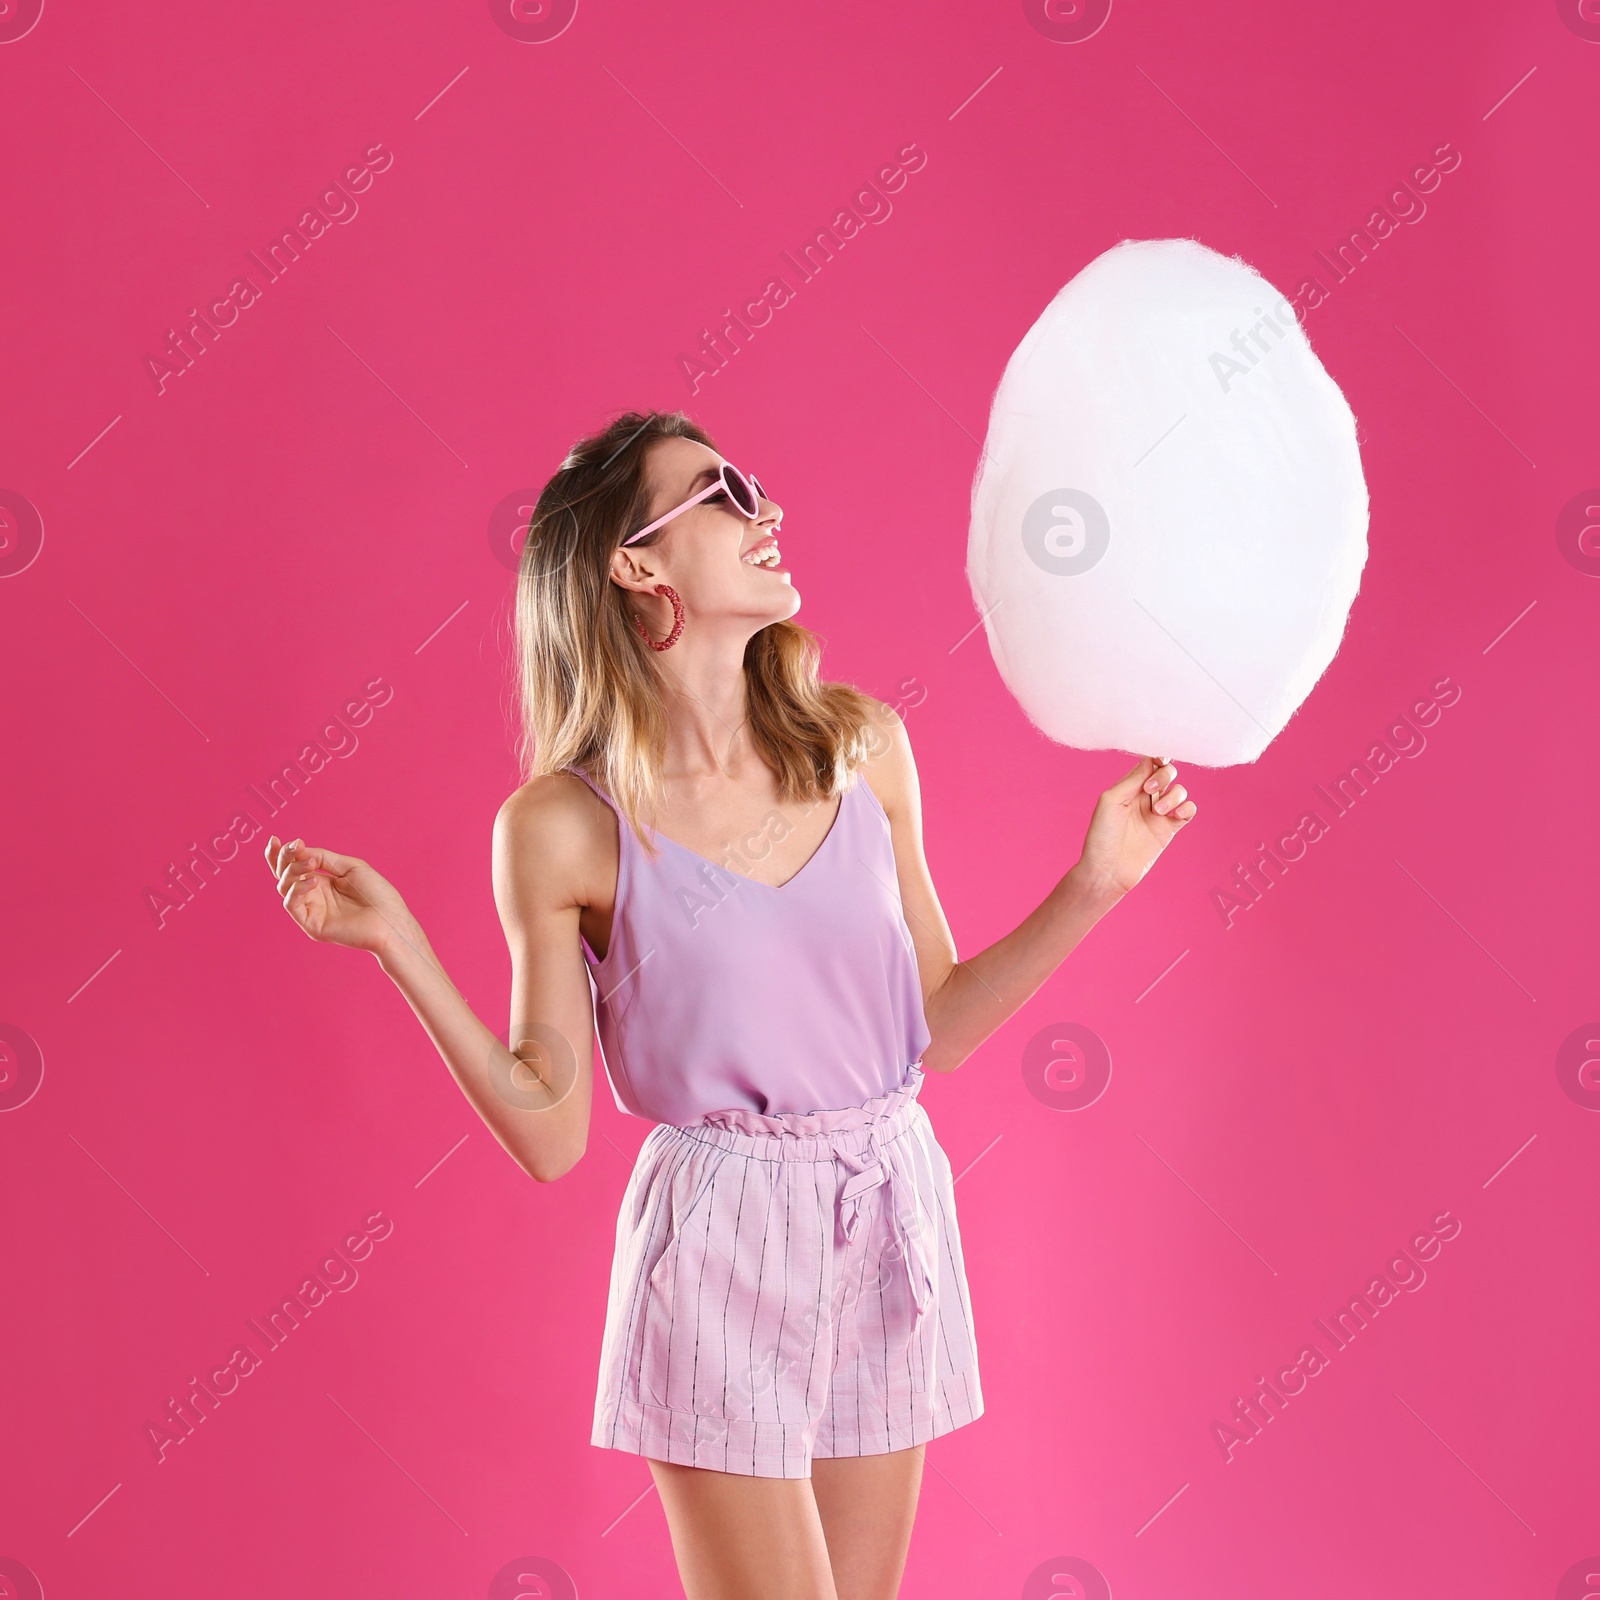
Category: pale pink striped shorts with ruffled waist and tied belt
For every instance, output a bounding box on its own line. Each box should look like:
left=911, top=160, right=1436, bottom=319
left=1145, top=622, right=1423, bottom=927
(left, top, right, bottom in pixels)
left=590, top=1066, right=984, bottom=1478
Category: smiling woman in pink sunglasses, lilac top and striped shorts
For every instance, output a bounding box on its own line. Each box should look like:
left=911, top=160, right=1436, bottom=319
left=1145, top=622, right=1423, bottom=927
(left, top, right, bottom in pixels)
left=267, top=411, right=1195, bottom=1600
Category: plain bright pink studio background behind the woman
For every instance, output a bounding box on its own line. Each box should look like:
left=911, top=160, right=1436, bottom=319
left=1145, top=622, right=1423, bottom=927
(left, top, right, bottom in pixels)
left=0, top=0, right=1600, bottom=1600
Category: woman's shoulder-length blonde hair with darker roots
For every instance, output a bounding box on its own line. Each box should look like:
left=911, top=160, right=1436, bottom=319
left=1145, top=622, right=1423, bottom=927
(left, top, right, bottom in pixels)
left=515, top=411, right=882, bottom=850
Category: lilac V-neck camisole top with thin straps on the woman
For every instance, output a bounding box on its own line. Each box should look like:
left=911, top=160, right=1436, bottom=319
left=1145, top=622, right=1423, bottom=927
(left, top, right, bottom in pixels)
left=571, top=768, right=930, bottom=1126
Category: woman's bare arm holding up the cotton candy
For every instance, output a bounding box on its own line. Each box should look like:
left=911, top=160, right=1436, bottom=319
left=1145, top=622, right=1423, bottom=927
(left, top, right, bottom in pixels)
left=864, top=706, right=1195, bottom=1072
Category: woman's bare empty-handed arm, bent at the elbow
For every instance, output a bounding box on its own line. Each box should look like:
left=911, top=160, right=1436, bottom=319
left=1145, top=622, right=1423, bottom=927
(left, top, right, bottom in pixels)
left=267, top=779, right=595, bottom=1182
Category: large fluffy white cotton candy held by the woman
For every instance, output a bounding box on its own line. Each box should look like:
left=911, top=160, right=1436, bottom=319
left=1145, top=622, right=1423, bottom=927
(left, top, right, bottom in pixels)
left=966, top=238, right=1366, bottom=766
